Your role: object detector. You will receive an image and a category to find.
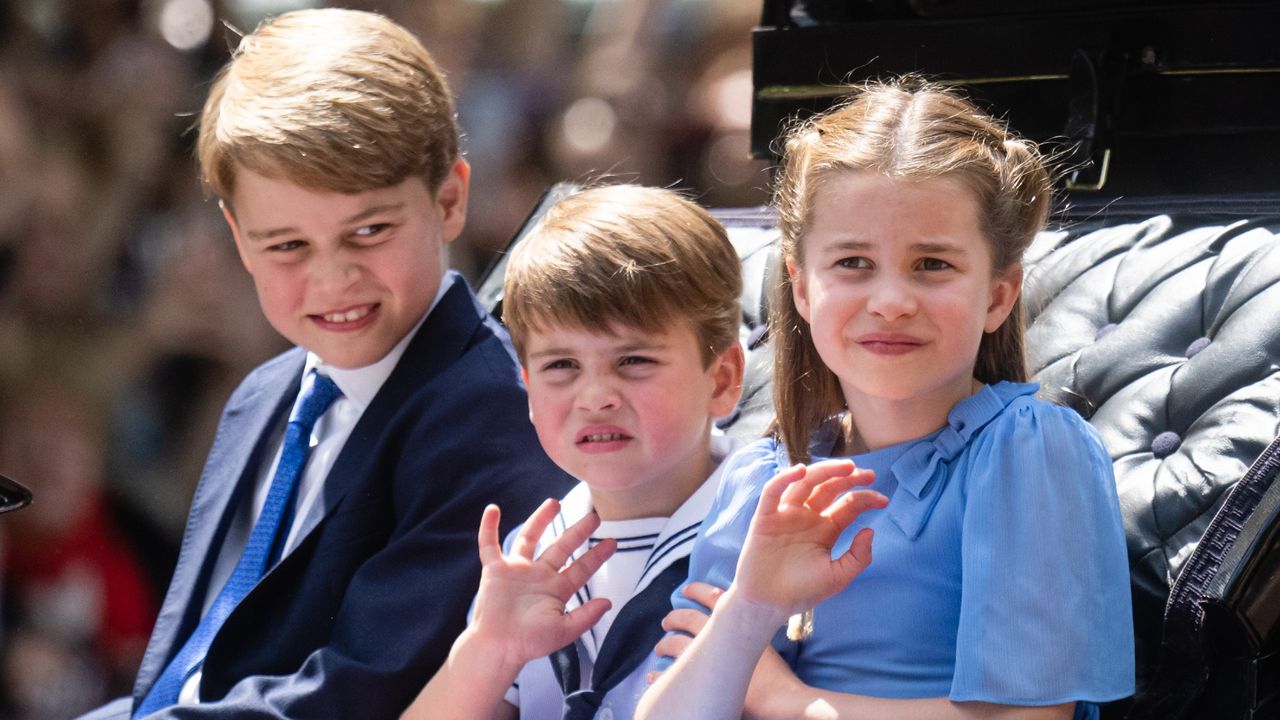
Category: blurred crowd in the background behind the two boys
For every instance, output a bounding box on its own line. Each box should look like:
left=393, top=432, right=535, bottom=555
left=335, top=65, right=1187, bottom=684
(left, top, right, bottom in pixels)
left=0, top=0, right=768, bottom=720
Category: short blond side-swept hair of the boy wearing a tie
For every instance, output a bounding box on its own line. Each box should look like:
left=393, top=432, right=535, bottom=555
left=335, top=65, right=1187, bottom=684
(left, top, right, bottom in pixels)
left=196, top=8, right=458, bottom=201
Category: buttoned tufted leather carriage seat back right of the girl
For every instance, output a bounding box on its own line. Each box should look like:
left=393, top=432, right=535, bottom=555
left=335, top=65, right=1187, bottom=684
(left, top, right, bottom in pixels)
left=1024, top=215, right=1280, bottom=597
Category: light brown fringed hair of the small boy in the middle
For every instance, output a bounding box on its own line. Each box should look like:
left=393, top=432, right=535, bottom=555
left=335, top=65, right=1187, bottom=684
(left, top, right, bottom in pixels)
left=503, top=184, right=742, bottom=366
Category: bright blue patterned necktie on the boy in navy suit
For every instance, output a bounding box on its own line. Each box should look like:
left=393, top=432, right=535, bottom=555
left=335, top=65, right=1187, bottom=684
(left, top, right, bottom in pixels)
left=133, top=373, right=342, bottom=717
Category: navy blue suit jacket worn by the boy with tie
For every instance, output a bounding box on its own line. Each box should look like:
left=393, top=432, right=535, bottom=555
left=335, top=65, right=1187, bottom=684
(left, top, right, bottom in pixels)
left=90, top=271, right=572, bottom=719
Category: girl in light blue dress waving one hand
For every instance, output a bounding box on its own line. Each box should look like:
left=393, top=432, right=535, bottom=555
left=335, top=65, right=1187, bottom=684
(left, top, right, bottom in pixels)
left=637, top=83, right=1134, bottom=719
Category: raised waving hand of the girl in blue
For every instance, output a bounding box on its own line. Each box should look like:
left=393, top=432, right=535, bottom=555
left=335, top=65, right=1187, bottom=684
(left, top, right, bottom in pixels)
left=733, top=460, right=888, bottom=616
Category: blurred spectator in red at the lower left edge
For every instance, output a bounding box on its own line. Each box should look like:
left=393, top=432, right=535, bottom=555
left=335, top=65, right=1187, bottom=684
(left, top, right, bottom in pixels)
left=0, top=375, right=157, bottom=720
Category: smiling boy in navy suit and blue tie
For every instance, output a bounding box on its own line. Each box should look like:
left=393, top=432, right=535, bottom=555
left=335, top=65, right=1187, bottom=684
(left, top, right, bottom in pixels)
left=74, top=9, right=568, bottom=719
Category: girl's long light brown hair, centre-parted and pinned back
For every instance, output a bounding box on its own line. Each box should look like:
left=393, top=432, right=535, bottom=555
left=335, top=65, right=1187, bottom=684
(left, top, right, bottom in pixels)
left=769, top=78, right=1052, bottom=462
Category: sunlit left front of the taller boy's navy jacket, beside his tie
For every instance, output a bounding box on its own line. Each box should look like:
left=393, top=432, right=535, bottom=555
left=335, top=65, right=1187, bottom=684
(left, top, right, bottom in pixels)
left=134, top=350, right=306, bottom=697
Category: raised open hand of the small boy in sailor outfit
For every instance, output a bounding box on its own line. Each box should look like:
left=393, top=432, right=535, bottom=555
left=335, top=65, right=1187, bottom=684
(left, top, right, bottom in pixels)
left=470, top=500, right=617, bottom=665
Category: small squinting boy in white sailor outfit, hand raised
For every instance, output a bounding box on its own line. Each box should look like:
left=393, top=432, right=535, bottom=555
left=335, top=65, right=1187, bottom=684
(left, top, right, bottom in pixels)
left=406, top=186, right=744, bottom=720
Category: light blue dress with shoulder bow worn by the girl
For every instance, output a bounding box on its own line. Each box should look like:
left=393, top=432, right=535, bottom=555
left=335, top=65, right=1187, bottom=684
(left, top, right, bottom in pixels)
left=672, top=383, right=1134, bottom=717
